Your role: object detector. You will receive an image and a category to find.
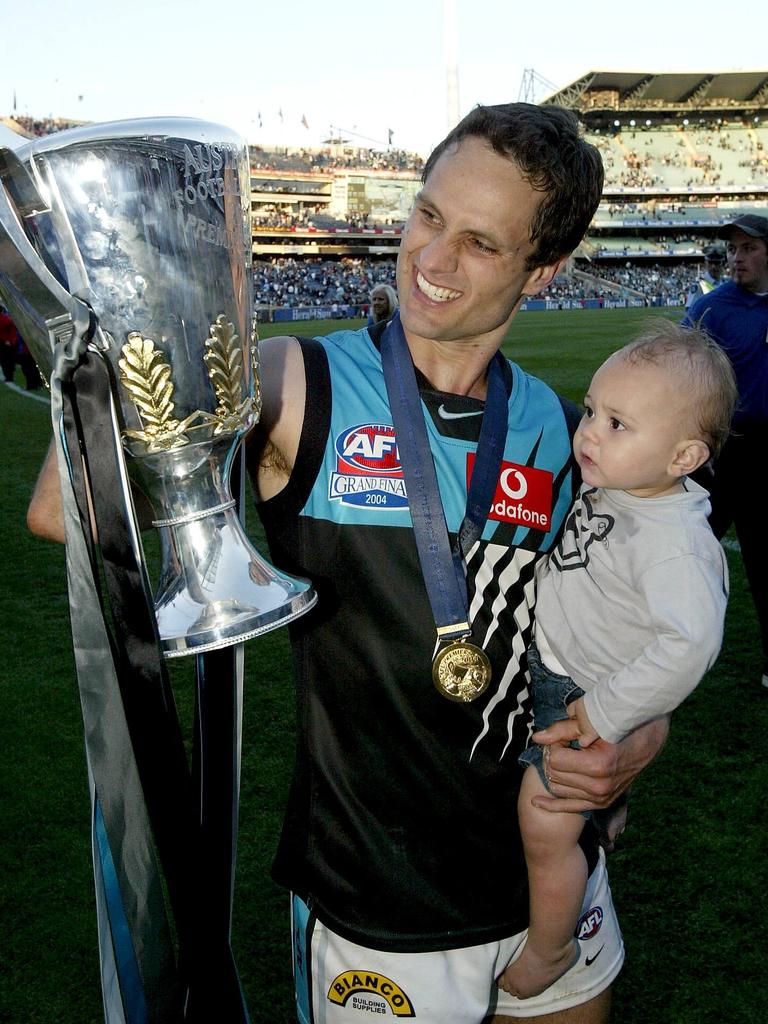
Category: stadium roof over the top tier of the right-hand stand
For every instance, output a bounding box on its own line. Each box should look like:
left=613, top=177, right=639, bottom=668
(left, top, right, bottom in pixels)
left=544, top=71, right=768, bottom=112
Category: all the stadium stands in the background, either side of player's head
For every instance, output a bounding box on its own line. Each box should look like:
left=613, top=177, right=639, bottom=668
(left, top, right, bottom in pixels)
left=4, top=71, right=768, bottom=318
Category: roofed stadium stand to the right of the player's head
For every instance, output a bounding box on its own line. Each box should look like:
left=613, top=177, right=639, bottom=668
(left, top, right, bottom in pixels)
left=545, top=71, right=768, bottom=302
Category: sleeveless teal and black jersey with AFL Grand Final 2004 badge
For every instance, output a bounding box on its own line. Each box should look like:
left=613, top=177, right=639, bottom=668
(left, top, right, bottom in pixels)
left=260, top=329, right=575, bottom=951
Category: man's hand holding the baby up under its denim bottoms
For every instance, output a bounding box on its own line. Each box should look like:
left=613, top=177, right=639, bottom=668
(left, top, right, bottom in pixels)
left=534, top=716, right=670, bottom=812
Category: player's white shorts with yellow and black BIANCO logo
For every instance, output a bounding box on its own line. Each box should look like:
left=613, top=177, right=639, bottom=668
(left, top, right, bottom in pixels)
left=292, top=850, right=624, bottom=1024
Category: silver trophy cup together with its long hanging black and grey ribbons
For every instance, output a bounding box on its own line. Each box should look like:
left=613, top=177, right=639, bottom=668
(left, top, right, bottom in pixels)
left=0, top=118, right=315, bottom=1024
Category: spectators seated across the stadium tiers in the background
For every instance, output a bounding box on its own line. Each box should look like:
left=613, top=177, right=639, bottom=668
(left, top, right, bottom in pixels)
left=5, top=109, right=757, bottom=315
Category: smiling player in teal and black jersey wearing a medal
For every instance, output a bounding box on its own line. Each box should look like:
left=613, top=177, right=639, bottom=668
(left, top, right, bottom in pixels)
left=249, top=103, right=666, bottom=1024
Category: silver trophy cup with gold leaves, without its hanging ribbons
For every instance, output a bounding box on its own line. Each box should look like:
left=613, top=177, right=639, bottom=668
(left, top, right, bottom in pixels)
left=0, top=118, right=315, bottom=657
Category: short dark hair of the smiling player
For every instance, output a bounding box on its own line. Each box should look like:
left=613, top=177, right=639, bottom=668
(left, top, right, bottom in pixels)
left=421, top=103, right=603, bottom=270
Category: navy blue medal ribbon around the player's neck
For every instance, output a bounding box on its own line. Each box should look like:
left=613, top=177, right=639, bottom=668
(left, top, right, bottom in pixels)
left=381, top=312, right=508, bottom=642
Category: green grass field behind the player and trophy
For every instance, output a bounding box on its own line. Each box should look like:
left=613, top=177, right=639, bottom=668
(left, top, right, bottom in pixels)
left=0, top=310, right=768, bottom=1024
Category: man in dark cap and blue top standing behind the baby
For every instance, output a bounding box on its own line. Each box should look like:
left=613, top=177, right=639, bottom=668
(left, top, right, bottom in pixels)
left=683, top=213, right=768, bottom=688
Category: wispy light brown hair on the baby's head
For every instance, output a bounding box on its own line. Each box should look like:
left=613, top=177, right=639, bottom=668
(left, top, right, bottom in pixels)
left=614, top=316, right=738, bottom=456
